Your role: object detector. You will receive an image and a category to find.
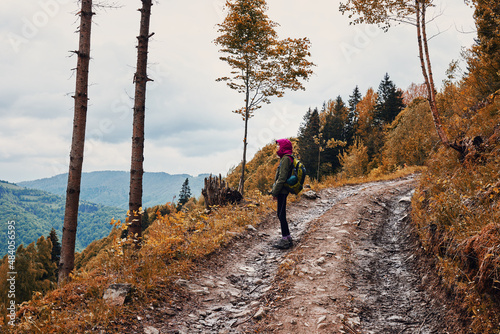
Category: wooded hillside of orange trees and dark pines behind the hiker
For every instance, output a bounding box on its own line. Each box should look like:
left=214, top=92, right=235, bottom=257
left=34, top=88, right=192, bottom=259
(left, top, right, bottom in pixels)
left=227, top=74, right=438, bottom=194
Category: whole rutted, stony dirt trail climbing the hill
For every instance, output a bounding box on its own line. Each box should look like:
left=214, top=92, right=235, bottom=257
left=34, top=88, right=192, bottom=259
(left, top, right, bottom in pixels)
left=140, top=177, right=462, bottom=334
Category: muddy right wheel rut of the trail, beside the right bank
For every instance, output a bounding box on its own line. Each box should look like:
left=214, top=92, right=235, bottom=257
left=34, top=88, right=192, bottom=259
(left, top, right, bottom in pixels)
left=348, top=190, right=458, bottom=334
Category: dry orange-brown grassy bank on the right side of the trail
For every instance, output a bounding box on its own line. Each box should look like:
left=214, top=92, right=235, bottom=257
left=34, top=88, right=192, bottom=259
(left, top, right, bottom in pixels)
left=412, top=93, right=500, bottom=334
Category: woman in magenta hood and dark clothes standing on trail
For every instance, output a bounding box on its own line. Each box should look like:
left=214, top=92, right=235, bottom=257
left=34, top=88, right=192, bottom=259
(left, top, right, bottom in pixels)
left=271, top=139, right=293, bottom=249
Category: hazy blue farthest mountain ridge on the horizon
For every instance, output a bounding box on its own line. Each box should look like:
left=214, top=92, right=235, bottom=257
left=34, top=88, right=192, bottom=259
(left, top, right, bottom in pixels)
left=18, top=171, right=209, bottom=210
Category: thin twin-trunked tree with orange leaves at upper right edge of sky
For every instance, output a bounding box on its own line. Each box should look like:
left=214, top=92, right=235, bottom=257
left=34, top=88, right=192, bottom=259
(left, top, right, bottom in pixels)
left=339, top=0, right=464, bottom=154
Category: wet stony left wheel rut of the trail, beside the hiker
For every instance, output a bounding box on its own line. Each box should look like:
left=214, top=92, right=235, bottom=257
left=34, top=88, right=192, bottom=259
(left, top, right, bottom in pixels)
left=151, top=184, right=371, bottom=334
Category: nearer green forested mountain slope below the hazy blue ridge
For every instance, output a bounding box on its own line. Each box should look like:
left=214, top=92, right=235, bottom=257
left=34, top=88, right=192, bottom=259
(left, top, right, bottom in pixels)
left=0, top=181, right=126, bottom=256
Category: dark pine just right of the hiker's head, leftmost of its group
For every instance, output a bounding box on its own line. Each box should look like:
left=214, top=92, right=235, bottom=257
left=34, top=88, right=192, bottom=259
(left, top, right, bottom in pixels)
left=298, top=108, right=320, bottom=178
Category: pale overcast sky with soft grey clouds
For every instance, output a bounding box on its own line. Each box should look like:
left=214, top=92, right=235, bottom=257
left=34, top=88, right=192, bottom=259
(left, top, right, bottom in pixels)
left=0, top=0, right=475, bottom=182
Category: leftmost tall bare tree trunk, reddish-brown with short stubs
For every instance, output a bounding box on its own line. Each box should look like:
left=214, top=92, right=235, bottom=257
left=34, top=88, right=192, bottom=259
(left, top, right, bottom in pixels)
left=58, top=0, right=94, bottom=284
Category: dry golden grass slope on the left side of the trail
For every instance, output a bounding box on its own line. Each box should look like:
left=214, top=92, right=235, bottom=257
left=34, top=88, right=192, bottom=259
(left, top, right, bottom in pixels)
left=2, top=193, right=273, bottom=334
